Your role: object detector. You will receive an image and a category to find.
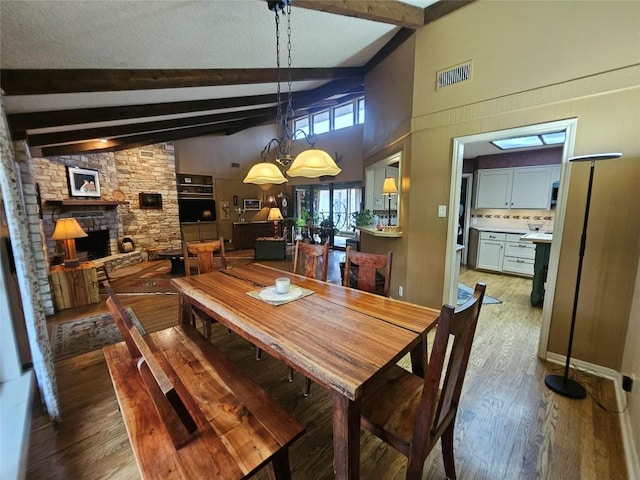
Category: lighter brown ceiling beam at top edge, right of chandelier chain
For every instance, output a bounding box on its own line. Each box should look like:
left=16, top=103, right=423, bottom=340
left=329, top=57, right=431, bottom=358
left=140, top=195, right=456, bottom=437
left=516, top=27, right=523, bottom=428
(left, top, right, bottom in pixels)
left=293, top=0, right=425, bottom=29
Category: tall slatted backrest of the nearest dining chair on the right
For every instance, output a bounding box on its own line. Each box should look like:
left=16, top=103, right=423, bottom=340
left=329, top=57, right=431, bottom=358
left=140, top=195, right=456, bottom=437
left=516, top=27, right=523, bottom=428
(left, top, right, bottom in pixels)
left=414, top=283, right=486, bottom=444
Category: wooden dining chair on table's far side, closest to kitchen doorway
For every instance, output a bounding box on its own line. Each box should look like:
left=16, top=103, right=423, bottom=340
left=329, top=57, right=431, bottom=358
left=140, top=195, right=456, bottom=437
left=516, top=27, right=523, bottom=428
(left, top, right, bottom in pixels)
left=342, top=246, right=393, bottom=297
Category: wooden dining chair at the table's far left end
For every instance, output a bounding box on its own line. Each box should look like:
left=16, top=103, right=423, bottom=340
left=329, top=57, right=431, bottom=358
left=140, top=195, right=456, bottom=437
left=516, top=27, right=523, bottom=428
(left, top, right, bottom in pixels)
left=182, top=237, right=227, bottom=340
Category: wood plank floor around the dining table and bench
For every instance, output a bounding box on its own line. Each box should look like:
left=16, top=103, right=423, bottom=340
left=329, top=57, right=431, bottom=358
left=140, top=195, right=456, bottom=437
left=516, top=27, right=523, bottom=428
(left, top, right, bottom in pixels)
left=27, top=252, right=627, bottom=480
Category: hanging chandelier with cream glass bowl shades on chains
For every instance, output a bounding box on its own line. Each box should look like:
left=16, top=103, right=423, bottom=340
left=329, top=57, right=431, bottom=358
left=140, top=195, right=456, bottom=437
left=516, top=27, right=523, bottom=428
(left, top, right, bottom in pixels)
left=244, top=0, right=342, bottom=185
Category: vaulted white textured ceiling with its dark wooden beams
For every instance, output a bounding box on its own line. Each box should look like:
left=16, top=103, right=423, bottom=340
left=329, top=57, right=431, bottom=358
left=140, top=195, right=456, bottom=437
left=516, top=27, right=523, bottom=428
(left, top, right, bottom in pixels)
left=0, top=0, right=471, bottom=156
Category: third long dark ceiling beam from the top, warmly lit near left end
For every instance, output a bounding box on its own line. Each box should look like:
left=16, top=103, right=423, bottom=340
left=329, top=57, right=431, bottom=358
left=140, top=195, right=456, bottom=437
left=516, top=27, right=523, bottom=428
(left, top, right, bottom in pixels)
left=27, top=107, right=276, bottom=147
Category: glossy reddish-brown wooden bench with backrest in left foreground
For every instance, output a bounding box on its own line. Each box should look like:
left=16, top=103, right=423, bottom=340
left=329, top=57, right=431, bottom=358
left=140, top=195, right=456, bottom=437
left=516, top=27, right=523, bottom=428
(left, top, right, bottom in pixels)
left=103, top=282, right=304, bottom=480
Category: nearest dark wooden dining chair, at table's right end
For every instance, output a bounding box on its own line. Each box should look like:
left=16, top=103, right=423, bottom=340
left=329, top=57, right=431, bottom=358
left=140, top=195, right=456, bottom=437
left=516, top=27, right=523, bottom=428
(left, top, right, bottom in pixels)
left=360, top=283, right=486, bottom=480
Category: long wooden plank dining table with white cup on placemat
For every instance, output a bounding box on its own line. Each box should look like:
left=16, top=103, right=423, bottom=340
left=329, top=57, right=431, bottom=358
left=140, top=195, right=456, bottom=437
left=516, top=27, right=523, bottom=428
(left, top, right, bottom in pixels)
left=172, top=263, right=439, bottom=479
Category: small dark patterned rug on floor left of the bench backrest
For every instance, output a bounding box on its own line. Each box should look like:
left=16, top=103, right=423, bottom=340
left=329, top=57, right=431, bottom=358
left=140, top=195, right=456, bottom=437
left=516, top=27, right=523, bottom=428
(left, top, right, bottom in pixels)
left=51, top=308, right=145, bottom=360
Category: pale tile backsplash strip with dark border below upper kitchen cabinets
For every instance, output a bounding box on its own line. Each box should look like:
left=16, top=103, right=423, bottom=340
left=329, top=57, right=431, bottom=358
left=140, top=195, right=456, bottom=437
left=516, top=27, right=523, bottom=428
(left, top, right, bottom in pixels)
left=469, top=209, right=556, bottom=232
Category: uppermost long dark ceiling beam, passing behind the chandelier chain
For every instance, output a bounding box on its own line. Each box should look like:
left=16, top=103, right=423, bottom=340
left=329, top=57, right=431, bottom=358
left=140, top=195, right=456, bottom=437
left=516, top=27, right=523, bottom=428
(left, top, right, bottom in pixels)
left=0, top=67, right=362, bottom=95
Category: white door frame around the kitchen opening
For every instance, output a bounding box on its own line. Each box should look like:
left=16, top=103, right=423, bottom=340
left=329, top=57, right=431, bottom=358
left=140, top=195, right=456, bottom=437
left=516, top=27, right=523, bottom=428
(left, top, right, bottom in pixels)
left=443, top=119, right=577, bottom=357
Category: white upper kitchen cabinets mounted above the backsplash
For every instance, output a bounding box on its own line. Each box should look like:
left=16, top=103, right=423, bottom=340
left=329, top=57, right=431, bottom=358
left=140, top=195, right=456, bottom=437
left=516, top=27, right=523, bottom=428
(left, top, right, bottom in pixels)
left=475, top=166, right=553, bottom=210
